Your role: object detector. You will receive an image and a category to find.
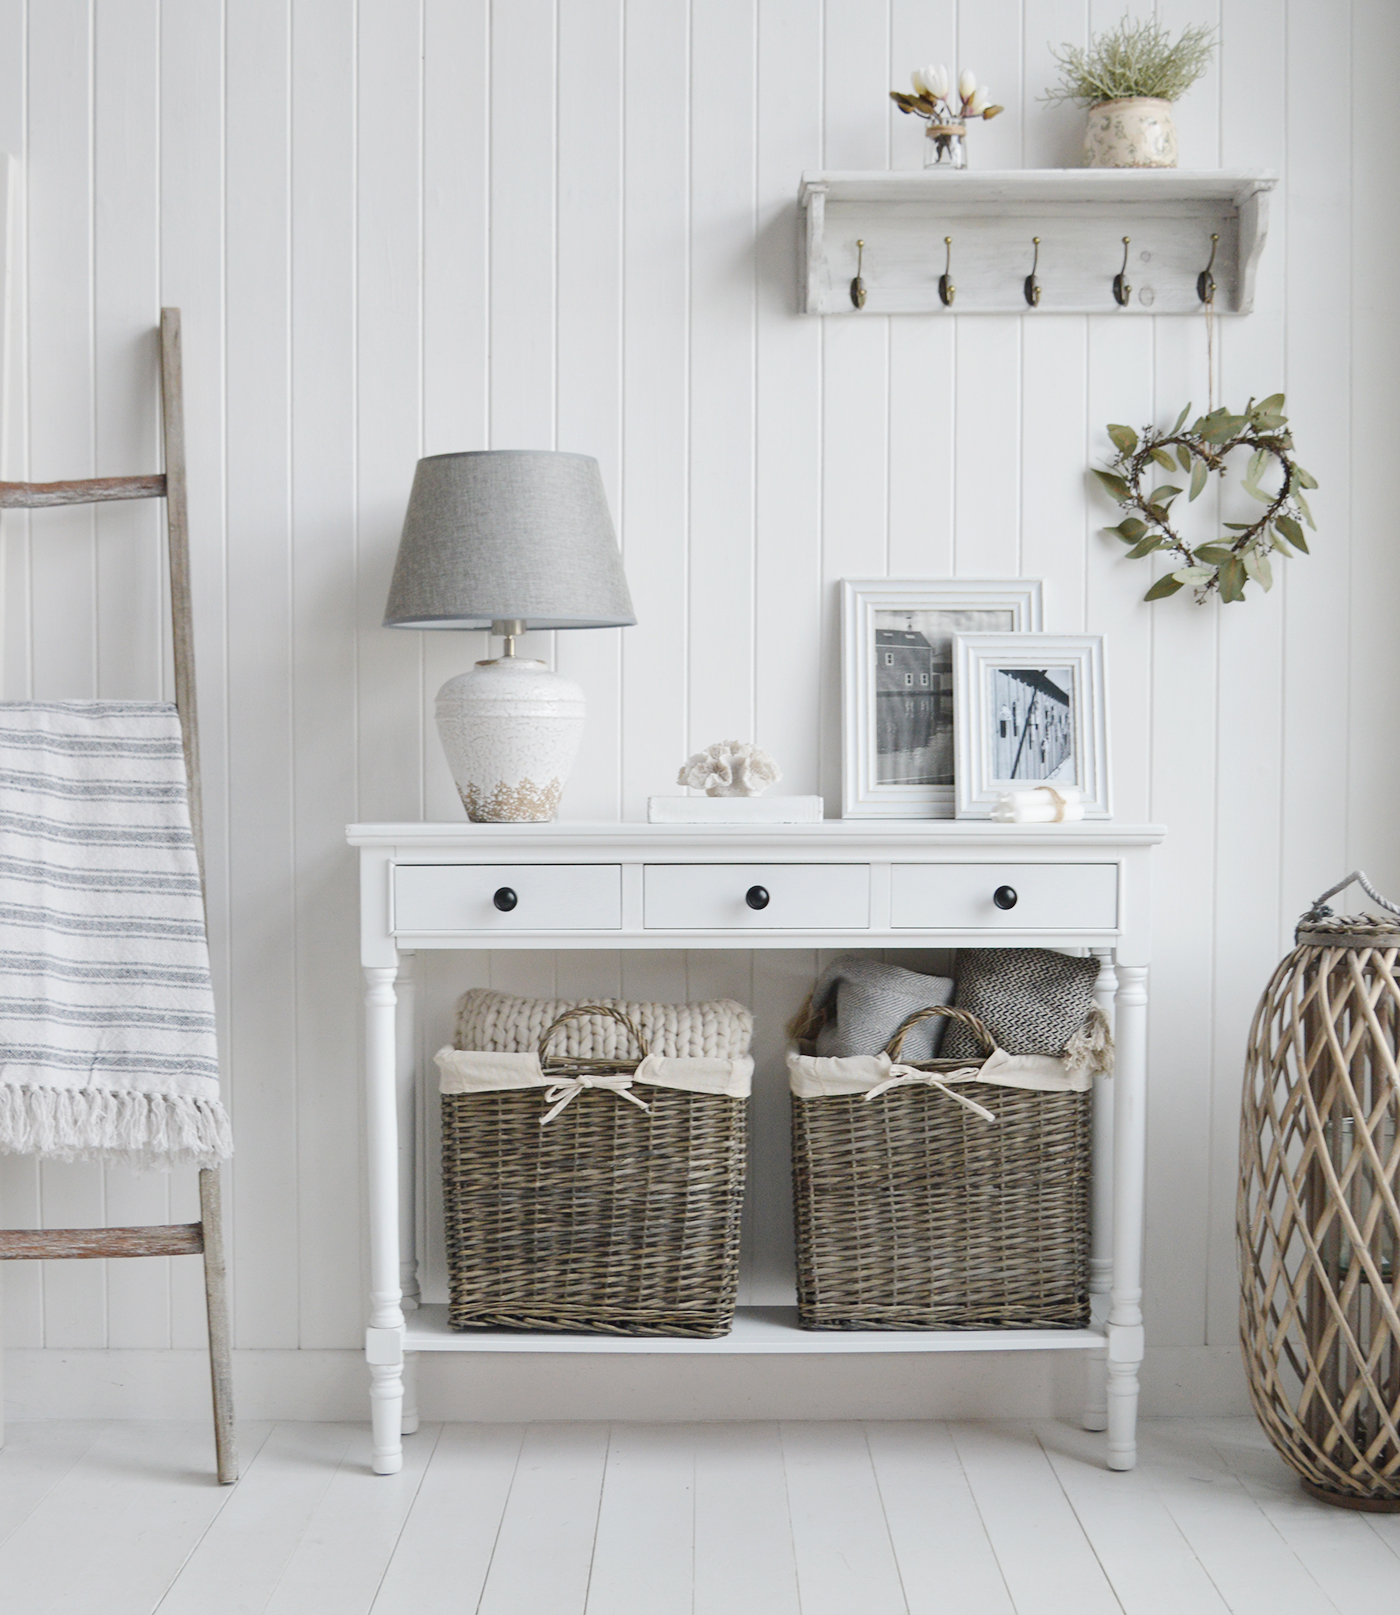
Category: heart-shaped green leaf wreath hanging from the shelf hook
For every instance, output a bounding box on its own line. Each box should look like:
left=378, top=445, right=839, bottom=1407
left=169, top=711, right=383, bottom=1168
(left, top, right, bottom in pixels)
left=1093, top=392, right=1318, bottom=604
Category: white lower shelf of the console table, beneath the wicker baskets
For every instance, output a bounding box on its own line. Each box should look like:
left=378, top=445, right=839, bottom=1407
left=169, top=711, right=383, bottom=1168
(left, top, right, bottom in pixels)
left=404, top=1303, right=1108, bottom=1357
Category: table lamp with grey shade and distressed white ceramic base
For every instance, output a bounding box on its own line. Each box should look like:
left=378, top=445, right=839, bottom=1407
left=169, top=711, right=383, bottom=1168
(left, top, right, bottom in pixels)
left=384, top=449, right=636, bottom=824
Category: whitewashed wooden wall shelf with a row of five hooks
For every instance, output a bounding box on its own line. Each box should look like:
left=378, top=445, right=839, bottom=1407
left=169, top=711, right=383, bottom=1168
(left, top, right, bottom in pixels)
left=798, top=168, right=1277, bottom=318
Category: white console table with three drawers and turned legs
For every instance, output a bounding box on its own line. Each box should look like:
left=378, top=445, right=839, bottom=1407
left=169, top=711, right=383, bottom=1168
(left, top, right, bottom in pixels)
left=347, top=819, right=1166, bottom=1474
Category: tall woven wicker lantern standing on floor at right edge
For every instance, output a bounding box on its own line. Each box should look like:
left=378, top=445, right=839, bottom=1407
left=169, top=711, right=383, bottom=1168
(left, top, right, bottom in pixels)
left=1237, top=872, right=1400, bottom=1512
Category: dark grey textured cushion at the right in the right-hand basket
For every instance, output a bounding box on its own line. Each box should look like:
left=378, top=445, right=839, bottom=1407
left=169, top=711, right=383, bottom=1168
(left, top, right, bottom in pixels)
left=943, top=948, right=1098, bottom=1059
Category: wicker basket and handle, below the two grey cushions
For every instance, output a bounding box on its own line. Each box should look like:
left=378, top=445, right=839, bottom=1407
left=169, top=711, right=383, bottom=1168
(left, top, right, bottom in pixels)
left=793, top=1006, right=1093, bottom=1329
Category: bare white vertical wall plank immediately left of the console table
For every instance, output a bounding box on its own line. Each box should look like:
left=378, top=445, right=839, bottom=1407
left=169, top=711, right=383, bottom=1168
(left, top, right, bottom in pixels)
left=287, top=0, right=360, bottom=1345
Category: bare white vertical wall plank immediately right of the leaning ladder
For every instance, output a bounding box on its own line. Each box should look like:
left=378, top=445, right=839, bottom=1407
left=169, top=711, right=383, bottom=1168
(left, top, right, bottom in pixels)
left=226, top=0, right=300, bottom=1347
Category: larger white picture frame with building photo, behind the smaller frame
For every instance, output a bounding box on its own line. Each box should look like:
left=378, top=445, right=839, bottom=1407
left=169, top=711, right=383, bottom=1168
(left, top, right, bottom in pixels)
left=841, top=578, right=1040, bottom=819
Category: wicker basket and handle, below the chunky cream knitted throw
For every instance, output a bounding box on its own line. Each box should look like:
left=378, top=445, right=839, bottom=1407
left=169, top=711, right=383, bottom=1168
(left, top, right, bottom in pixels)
left=442, top=1005, right=748, bottom=1339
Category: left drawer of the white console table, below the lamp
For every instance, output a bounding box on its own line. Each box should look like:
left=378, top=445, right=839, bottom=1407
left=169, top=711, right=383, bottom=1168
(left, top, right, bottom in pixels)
left=394, top=864, right=622, bottom=932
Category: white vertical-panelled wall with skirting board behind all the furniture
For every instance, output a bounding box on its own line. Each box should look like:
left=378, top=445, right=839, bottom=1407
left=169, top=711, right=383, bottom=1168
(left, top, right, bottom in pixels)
left=0, top=0, right=1400, bottom=1418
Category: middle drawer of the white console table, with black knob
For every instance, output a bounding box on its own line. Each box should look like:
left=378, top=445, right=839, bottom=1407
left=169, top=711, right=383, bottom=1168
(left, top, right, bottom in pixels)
left=643, top=864, right=870, bottom=930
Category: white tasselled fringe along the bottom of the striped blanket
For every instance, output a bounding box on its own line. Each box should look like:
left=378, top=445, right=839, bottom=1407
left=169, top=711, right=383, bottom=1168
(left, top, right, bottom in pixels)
left=0, top=1084, right=233, bottom=1172
